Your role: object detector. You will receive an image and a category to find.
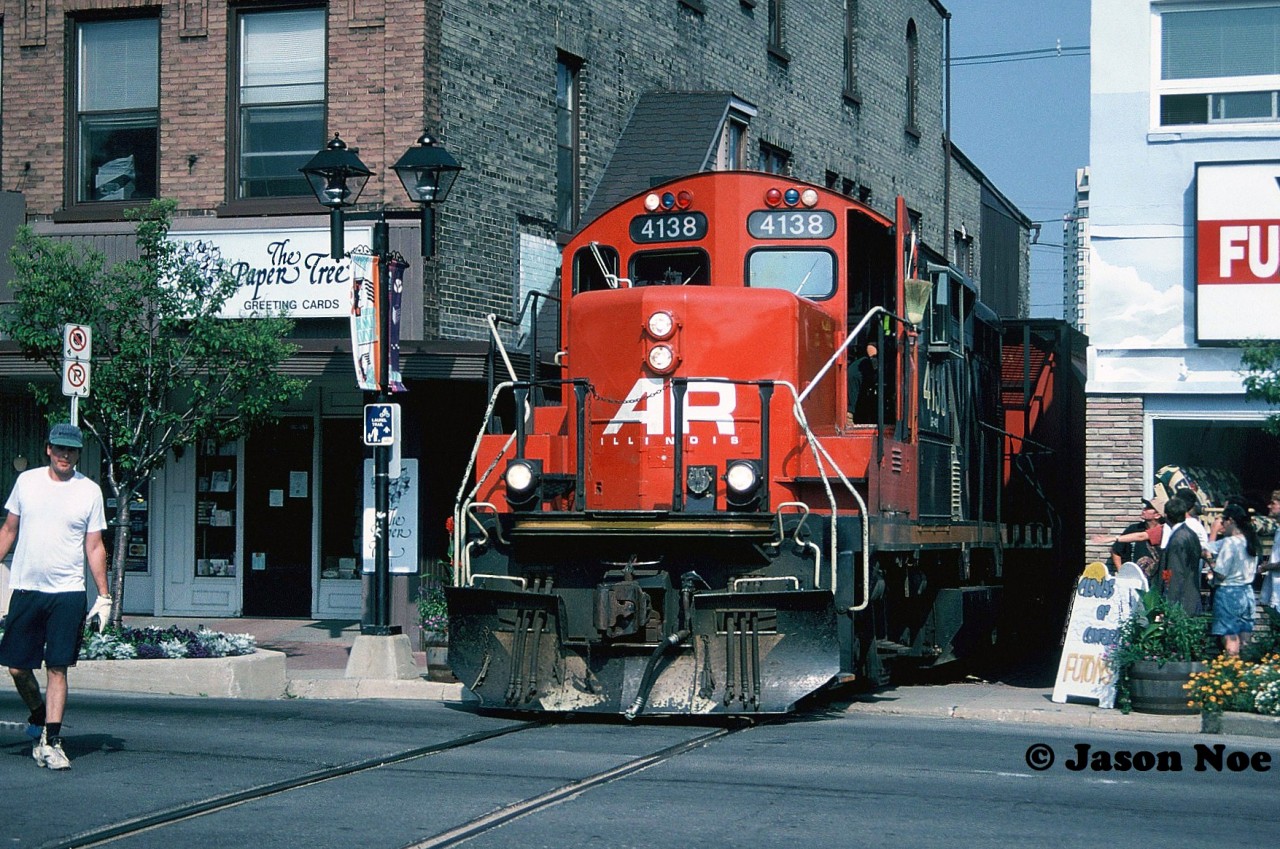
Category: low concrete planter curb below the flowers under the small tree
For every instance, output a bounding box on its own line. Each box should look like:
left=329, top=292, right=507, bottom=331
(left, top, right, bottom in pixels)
left=45, top=649, right=288, bottom=699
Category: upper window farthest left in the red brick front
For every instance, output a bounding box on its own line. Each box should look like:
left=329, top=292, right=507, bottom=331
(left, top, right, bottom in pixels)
left=73, top=18, right=160, bottom=204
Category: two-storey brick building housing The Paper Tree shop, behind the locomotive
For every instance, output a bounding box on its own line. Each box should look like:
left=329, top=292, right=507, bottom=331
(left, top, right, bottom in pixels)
left=0, top=0, right=1029, bottom=617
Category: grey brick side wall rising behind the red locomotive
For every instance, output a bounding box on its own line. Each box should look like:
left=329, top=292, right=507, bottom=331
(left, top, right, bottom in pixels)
left=429, top=0, right=957, bottom=337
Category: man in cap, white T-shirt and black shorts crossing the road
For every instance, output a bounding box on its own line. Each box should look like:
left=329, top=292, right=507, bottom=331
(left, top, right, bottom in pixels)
left=0, top=424, right=111, bottom=770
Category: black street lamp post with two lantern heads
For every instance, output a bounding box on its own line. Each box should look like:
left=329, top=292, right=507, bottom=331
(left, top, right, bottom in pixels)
left=300, top=132, right=462, bottom=636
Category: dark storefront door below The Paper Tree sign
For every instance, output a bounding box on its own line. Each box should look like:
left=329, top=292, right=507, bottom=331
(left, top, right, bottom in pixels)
left=242, top=417, right=315, bottom=616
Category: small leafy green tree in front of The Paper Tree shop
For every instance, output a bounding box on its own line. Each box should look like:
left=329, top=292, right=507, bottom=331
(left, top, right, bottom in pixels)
left=0, top=201, right=306, bottom=626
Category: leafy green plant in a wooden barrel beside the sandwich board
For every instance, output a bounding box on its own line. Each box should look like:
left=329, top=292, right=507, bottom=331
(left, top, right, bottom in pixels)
left=1107, top=589, right=1216, bottom=713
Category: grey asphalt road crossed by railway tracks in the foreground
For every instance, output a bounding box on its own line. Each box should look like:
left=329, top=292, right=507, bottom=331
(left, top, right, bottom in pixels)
left=0, top=690, right=1280, bottom=849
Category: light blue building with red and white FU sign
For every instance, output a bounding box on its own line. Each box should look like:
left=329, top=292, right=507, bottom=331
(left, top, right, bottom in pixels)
left=1084, top=0, right=1280, bottom=556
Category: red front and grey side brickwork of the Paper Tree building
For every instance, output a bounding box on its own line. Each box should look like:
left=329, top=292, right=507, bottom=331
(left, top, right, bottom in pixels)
left=0, top=0, right=998, bottom=339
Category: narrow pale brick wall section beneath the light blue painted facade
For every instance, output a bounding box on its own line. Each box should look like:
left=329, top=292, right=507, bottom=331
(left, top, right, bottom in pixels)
left=1084, top=396, right=1143, bottom=562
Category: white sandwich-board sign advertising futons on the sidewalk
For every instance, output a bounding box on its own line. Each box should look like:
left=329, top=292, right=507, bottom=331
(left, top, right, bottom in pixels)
left=1053, top=562, right=1147, bottom=708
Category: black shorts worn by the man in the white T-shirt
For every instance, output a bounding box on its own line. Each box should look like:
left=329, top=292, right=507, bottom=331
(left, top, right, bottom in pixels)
left=0, top=589, right=86, bottom=670
